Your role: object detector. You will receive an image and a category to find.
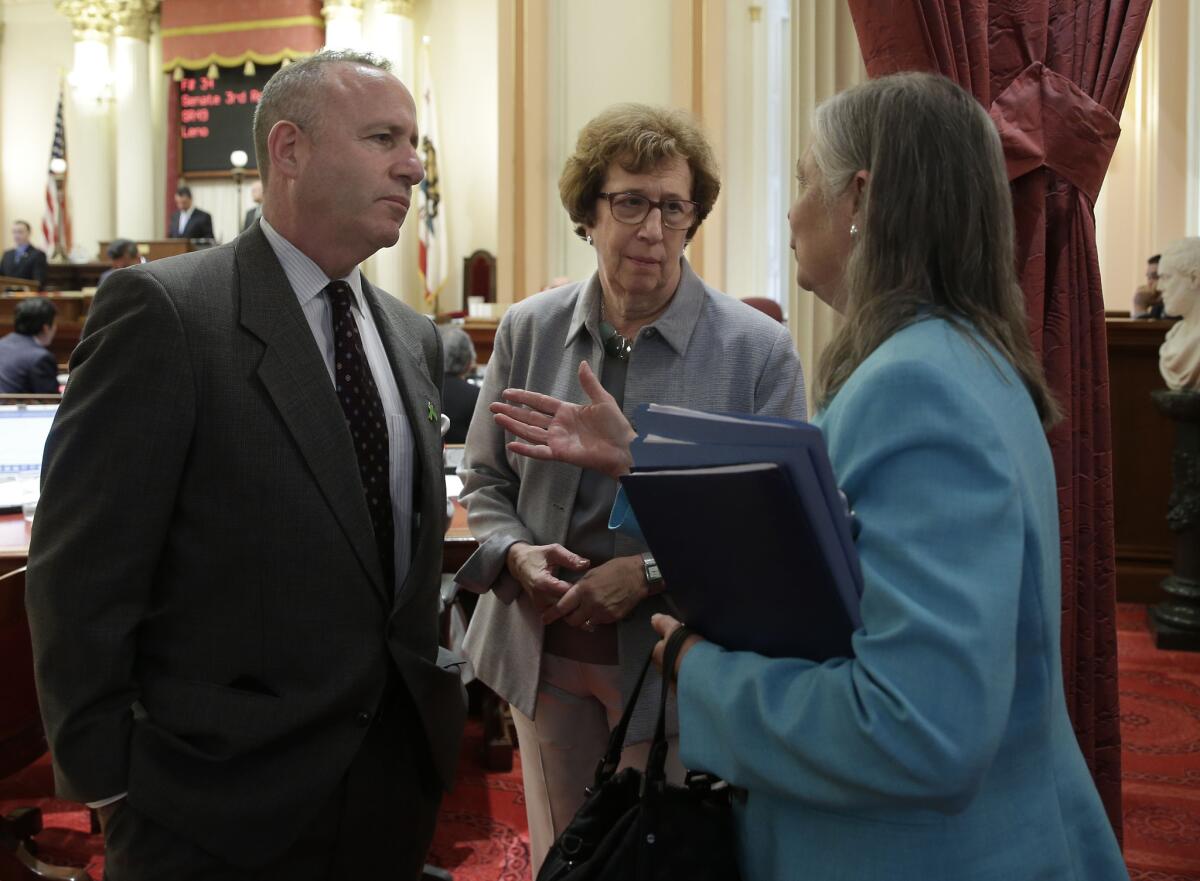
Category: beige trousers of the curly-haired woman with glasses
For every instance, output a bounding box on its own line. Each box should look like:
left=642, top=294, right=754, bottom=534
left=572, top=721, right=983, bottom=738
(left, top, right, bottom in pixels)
left=512, top=654, right=685, bottom=879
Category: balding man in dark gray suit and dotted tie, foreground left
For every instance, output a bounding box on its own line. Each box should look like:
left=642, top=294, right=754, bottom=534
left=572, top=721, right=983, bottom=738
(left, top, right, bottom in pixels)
left=28, top=52, right=464, bottom=881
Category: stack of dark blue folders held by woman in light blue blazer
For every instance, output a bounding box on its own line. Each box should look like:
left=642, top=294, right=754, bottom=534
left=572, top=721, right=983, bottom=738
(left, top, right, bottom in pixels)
left=620, top=404, right=863, bottom=661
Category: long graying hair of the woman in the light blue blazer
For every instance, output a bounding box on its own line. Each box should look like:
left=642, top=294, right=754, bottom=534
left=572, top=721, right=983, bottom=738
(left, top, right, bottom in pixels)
left=811, top=73, right=1058, bottom=427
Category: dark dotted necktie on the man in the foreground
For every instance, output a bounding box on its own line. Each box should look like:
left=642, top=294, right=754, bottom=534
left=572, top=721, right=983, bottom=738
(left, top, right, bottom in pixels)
left=325, top=281, right=396, bottom=591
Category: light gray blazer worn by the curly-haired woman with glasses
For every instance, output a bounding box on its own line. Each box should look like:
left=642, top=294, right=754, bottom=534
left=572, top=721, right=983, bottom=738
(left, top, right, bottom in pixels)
left=456, top=260, right=804, bottom=742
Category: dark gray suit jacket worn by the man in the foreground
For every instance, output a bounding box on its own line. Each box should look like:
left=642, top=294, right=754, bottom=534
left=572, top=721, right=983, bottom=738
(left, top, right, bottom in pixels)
left=28, top=228, right=464, bottom=863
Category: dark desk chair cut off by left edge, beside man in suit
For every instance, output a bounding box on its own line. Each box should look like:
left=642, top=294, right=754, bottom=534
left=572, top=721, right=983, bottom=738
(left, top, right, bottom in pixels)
left=0, top=568, right=89, bottom=881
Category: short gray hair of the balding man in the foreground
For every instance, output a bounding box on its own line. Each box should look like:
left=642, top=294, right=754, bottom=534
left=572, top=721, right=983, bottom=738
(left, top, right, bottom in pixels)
left=254, top=49, right=391, bottom=187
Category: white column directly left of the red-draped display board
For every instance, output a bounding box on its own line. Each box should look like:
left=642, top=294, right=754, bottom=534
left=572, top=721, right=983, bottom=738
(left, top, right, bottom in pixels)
left=109, top=0, right=158, bottom=240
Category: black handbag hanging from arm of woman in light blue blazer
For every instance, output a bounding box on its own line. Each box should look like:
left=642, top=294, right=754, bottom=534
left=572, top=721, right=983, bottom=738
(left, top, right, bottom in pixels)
left=538, top=627, right=739, bottom=881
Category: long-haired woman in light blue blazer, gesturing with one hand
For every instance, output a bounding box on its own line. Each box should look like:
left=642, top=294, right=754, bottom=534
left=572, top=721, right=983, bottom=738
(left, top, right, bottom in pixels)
left=493, top=73, right=1128, bottom=881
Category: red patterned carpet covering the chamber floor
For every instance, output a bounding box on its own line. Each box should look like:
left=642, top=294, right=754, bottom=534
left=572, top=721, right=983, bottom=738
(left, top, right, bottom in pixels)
left=0, top=605, right=1200, bottom=881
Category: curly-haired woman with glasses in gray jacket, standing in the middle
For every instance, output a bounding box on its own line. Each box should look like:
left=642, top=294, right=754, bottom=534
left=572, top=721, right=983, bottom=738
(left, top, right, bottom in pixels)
left=456, top=104, right=804, bottom=875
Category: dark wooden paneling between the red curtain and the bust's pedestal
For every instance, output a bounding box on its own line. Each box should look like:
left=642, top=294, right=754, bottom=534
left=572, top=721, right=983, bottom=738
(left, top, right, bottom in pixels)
left=1105, top=317, right=1175, bottom=603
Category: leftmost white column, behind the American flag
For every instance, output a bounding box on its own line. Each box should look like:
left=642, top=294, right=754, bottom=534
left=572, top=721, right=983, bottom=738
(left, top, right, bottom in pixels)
left=55, top=0, right=113, bottom=259
